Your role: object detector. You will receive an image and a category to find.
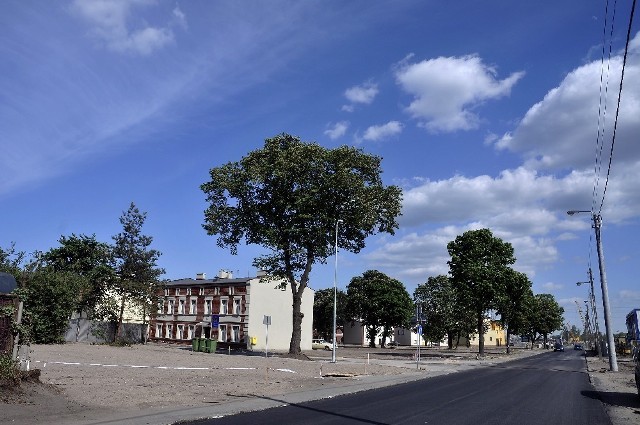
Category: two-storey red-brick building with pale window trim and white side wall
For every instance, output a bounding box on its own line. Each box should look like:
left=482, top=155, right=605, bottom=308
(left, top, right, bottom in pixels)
left=149, top=271, right=314, bottom=351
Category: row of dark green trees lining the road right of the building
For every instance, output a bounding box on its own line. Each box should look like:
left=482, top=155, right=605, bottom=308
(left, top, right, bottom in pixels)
left=314, top=229, right=564, bottom=355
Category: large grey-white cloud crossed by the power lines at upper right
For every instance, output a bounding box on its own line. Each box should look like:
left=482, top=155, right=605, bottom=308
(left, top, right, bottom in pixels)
left=495, top=31, right=640, bottom=170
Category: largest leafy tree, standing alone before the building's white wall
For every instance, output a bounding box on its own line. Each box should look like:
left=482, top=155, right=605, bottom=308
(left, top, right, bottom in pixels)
left=201, top=133, right=401, bottom=355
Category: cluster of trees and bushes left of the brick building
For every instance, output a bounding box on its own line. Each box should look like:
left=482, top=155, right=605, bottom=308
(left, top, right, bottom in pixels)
left=0, top=203, right=164, bottom=343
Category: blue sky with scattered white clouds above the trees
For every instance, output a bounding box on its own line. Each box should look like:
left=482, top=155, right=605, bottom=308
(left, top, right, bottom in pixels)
left=0, top=0, right=640, bottom=331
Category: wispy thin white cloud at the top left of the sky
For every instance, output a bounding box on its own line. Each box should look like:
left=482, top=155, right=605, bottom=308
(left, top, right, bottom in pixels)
left=73, top=0, right=186, bottom=55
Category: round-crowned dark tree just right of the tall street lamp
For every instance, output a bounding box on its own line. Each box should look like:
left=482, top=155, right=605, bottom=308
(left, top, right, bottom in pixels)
left=345, top=270, right=414, bottom=347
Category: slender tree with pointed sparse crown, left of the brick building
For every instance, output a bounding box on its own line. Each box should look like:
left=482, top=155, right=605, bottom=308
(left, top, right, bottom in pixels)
left=113, top=202, right=164, bottom=338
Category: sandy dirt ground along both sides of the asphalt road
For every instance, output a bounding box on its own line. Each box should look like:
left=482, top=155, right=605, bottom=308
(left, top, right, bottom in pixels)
left=0, top=344, right=640, bottom=425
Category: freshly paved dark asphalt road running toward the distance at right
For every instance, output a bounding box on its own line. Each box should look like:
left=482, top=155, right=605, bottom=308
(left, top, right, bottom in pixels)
left=185, top=350, right=611, bottom=425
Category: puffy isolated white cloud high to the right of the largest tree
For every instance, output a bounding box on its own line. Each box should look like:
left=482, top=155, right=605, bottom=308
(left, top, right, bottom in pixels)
left=396, top=55, right=524, bottom=132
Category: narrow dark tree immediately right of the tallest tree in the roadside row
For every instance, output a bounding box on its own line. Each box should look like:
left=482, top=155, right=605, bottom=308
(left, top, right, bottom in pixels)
left=496, top=269, right=533, bottom=353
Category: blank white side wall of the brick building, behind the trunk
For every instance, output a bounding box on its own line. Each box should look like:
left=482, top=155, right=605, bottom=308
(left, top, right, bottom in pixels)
left=247, top=278, right=314, bottom=351
